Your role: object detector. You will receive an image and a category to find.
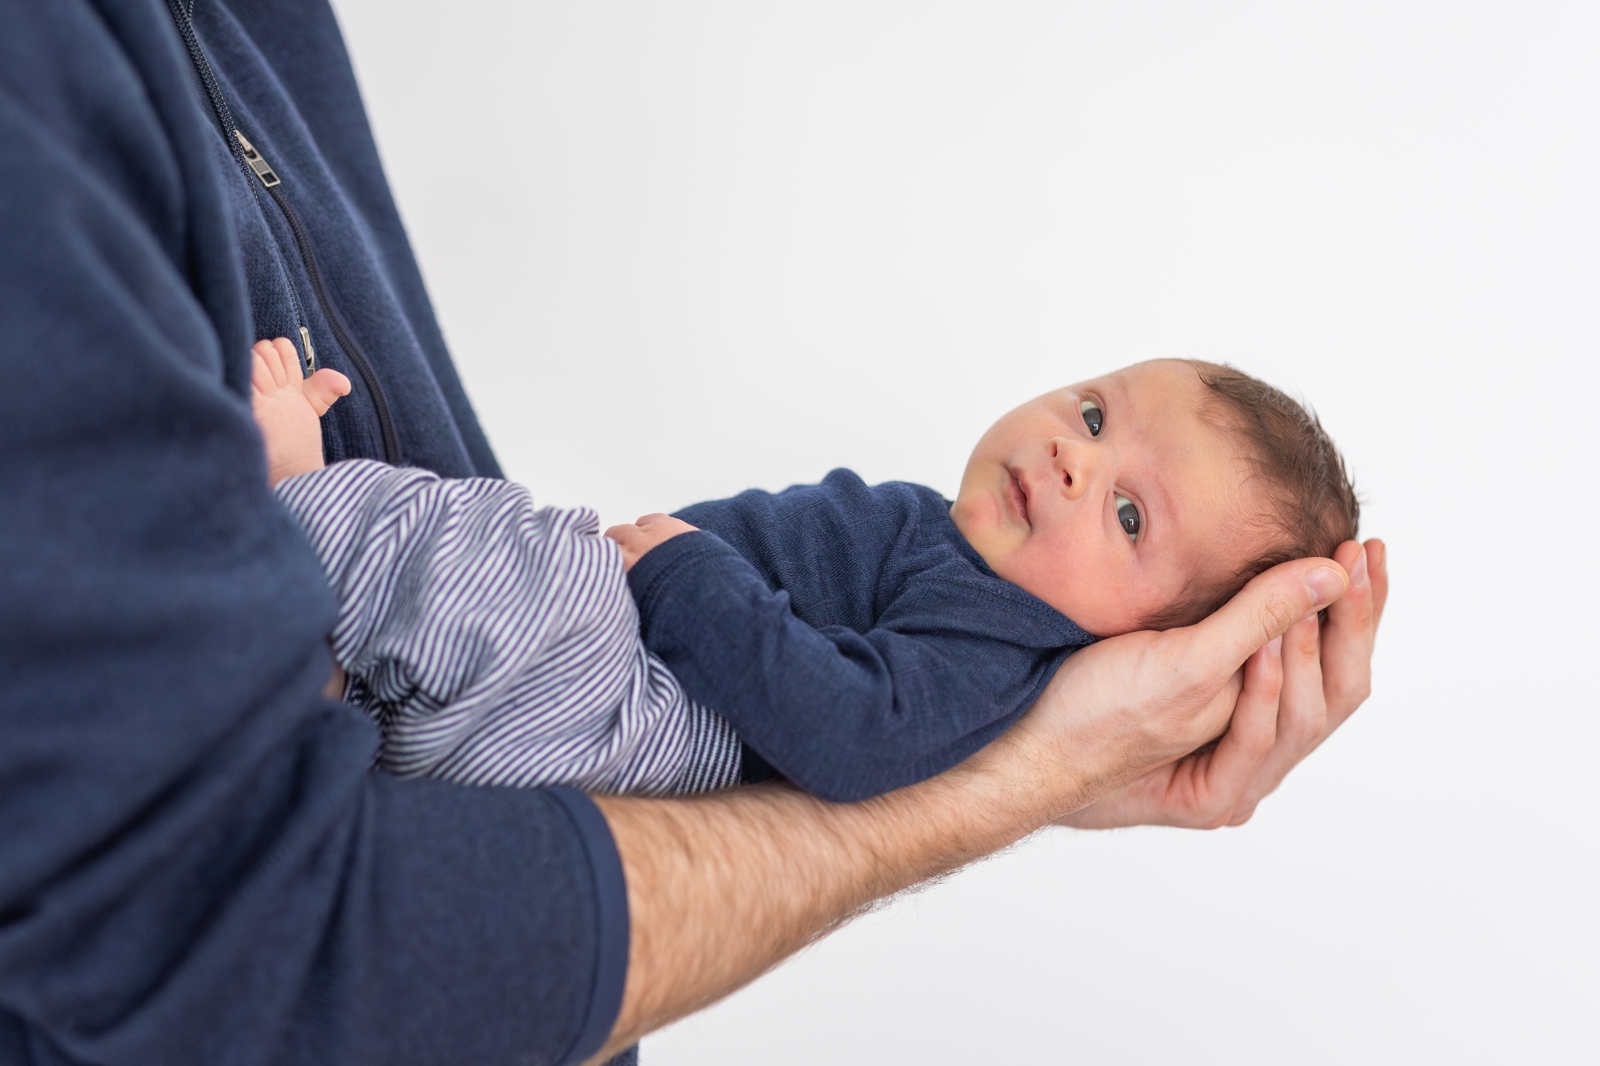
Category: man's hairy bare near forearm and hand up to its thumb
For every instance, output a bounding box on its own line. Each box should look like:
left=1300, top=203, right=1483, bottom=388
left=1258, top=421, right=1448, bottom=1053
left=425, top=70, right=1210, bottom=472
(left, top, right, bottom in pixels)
left=582, top=547, right=1346, bottom=1061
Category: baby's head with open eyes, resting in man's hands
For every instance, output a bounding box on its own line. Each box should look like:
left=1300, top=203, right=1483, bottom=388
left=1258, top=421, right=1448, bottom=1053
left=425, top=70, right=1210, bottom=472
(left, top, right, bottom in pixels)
left=950, top=359, right=1360, bottom=637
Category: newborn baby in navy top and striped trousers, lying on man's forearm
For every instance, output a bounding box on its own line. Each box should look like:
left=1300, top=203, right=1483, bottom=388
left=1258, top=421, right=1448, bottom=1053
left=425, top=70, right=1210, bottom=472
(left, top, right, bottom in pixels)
left=254, top=341, right=1357, bottom=800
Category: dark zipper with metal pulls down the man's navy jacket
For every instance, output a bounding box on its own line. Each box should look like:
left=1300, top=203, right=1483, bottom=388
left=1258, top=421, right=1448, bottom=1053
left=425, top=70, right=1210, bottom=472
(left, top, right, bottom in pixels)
left=166, top=0, right=402, bottom=466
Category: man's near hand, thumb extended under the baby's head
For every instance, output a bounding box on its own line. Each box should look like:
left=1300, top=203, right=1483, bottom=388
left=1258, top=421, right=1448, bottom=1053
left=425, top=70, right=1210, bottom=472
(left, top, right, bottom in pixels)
left=972, top=547, right=1350, bottom=826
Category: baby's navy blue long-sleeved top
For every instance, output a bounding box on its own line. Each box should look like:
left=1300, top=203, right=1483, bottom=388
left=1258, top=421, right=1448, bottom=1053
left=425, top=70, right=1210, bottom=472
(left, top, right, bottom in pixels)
left=629, top=471, right=1093, bottom=802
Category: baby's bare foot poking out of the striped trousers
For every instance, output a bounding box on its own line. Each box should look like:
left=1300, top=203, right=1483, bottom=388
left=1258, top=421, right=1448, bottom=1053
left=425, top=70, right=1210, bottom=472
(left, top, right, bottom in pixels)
left=250, top=336, right=350, bottom=485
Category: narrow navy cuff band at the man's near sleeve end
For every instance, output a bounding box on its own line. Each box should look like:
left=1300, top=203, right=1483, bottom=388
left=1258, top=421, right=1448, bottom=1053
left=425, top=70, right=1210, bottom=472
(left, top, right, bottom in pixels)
left=546, top=787, right=629, bottom=1066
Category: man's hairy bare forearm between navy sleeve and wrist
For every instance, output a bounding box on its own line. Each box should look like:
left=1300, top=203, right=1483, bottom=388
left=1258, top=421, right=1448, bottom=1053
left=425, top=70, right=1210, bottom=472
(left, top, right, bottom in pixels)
left=595, top=723, right=1110, bottom=1058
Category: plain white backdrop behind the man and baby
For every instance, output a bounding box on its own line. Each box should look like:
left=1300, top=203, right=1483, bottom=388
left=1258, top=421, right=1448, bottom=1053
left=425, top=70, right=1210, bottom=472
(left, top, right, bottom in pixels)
left=338, top=0, right=1600, bottom=1066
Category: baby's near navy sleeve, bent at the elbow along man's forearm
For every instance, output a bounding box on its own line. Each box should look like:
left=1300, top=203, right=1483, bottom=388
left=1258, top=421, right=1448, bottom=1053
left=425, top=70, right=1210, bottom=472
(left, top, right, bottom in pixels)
left=629, top=531, right=1059, bottom=802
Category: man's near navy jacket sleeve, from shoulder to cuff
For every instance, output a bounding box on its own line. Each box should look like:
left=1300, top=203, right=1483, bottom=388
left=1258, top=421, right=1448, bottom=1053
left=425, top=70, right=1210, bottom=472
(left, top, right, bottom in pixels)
left=0, top=0, right=627, bottom=1064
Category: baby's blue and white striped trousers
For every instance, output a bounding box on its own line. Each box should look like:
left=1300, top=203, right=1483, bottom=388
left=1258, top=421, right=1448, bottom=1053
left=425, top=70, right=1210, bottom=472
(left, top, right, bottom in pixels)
left=278, top=459, right=739, bottom=794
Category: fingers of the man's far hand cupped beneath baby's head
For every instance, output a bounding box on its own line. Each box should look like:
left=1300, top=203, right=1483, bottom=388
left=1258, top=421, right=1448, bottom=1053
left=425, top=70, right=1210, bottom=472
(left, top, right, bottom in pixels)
left=1062, top=539, right=1389, bottom=829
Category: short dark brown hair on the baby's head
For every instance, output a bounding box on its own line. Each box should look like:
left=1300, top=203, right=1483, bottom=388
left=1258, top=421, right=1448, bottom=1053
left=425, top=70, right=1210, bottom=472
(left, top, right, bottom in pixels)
left=1146, top=360, right=1362, bottom=629
